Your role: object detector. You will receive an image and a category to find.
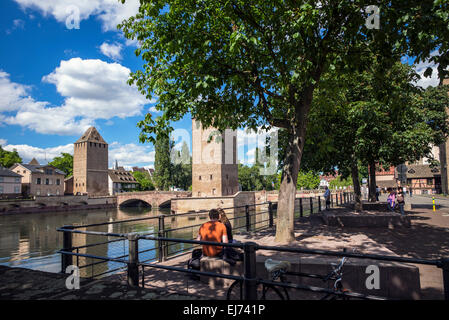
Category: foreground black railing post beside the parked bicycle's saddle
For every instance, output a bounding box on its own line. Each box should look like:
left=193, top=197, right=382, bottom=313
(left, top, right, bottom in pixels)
left=243, top=242, right=257, bottom=300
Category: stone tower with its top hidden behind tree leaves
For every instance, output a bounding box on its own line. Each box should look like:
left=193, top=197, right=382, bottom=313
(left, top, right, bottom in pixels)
left=192, top=119, right=239, bottom=197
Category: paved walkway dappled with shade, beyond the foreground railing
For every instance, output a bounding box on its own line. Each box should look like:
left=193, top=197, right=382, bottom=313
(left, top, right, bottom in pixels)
left=103, top=200, right=449, bottom=299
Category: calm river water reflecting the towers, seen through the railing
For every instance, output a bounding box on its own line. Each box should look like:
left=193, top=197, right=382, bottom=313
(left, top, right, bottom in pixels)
left=0, top=208, right=207, bottom=276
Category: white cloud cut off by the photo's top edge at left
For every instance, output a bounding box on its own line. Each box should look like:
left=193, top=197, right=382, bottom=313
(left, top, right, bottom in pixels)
left=15, top=0, right=139, bottom=31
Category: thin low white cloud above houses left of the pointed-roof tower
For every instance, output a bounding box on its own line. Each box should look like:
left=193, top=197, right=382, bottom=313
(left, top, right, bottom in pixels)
left=4, top=143, right=73, bottom=164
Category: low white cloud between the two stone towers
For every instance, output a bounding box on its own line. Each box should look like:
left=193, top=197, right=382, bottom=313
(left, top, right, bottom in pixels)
left=109, top=141, right=155, bottom=168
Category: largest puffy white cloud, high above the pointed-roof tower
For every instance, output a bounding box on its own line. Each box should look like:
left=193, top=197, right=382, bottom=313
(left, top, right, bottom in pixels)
left=0, top=58, right=149, bottom=135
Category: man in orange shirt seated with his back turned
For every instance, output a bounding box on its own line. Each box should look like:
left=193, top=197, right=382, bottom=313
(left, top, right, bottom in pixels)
left=196, top=209, right=228, bottom=257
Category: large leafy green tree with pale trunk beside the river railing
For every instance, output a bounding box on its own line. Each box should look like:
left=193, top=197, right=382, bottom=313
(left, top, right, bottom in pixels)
left=119, top=0, right=448, bottom=242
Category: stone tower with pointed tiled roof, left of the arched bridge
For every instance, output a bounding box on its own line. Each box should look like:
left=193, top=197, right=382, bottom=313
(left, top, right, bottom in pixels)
left=73, top=127, right=109, bottom=195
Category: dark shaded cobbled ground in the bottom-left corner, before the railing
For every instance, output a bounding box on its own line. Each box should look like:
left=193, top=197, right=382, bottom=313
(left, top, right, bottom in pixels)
left=0, top=266, right=204, bottom=300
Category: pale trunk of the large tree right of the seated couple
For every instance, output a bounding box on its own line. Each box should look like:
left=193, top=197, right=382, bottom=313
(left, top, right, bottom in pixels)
left=275, top=126, right=305, bottom=243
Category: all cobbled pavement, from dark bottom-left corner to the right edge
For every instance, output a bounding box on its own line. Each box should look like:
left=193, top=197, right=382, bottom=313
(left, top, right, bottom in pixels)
left=0, top=197, right=449, bottom=299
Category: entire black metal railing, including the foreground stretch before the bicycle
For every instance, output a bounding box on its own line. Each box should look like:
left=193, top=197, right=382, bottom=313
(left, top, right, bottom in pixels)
left=58, top=193, right=442, bottom=300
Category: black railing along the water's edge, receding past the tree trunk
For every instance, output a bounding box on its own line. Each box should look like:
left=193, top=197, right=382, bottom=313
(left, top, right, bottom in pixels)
left=58, top=194, right=352, bottom=277
